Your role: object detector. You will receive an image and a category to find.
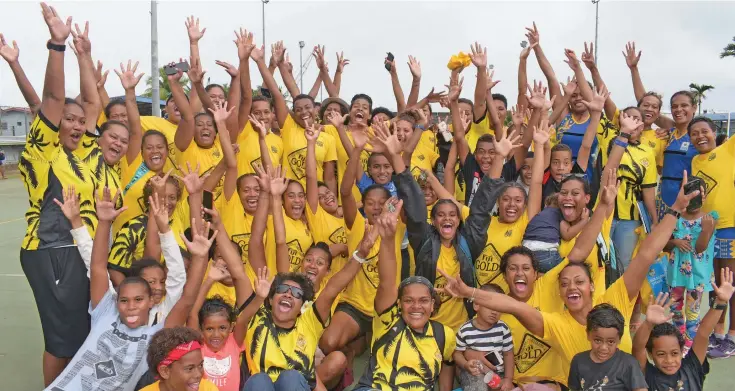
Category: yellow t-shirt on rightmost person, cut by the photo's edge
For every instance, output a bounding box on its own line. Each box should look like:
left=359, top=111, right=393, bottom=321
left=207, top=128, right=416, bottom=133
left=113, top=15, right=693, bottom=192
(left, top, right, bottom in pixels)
left=692, top=137, right=735, bottom=229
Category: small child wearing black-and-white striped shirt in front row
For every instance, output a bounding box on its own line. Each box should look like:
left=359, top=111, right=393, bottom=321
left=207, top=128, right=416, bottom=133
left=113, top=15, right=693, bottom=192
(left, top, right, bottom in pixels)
left=453, top=284, right=515, bottom=391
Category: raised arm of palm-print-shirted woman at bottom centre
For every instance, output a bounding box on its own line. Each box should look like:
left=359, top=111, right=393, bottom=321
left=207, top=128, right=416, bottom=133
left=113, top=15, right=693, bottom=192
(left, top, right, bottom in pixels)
left=374, top=197, right=403, bottom=314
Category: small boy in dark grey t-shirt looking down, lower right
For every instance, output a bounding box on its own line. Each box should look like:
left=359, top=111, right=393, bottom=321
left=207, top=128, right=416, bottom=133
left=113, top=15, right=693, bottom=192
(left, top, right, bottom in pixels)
left=568, top=303, right=648, bottom=391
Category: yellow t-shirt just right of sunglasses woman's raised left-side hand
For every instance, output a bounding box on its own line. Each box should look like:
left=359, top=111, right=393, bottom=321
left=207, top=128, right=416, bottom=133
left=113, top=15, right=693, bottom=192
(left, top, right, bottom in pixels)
left=217, top=192, right=258, bottom=284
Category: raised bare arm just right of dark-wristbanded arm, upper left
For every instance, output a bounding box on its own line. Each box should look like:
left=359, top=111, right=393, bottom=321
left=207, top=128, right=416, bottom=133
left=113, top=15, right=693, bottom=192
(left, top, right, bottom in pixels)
left=71, top=22, right=101, bottom=132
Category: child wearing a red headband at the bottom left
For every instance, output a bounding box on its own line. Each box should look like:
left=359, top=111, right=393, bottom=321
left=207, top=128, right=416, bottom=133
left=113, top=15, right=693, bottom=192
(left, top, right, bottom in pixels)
left=141, top=327, right=218, bottom=391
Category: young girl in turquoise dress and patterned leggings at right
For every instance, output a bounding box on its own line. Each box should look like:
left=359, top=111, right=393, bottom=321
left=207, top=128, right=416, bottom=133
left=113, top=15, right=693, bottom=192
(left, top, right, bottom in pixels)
left=666, top=185, right=718, bottom=354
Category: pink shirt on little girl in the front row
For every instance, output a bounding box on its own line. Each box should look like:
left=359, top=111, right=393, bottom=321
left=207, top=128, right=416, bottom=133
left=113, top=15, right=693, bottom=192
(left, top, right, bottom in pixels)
left=202, top=334, right=245, bottom=391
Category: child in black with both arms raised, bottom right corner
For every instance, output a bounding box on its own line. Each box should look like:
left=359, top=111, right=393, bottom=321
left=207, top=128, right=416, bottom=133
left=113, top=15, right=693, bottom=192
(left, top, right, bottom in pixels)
left=633, top=268, right=735, bottom=391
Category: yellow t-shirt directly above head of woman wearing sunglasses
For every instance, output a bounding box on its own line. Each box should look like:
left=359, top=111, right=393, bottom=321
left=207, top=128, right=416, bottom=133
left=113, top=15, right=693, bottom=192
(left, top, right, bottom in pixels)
left=265, top=213, right=314, bottom=275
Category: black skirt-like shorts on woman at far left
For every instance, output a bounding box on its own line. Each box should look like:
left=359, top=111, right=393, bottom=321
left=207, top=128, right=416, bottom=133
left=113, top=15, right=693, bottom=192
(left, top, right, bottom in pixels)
left=20, top=246, right=89, bottom=358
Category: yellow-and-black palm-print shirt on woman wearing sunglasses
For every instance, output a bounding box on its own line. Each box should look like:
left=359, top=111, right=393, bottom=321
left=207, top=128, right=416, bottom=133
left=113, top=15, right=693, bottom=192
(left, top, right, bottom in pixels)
left=245, top=306, right=331, bottom=384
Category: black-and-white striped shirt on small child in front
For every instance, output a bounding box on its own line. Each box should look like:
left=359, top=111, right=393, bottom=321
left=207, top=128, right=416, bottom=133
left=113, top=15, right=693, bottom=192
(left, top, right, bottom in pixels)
left=456, top=319, right=513, bottom=373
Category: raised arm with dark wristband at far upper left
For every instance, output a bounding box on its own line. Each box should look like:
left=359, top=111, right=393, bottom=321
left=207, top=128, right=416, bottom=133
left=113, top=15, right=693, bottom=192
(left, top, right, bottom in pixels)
left=40, top=3, right=72, bottom=125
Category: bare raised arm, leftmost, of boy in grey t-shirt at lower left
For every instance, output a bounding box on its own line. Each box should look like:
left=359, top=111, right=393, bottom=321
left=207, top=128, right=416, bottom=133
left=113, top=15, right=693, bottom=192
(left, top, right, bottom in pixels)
left=89, top=187, right=127, bottom=309
